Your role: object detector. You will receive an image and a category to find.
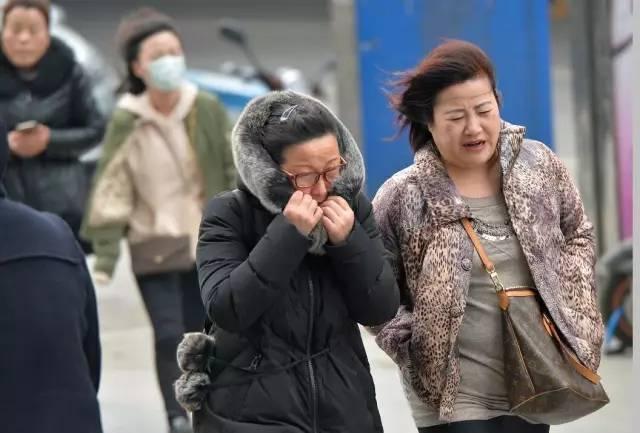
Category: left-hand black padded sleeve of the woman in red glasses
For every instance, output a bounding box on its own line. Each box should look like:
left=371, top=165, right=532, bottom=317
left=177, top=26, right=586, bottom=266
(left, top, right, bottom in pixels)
left=196, top=193, right=311, bottom=332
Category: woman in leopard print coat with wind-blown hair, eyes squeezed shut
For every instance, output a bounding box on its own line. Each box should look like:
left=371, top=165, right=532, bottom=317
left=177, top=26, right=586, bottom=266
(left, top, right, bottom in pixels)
left=374, top=41, right=603, bottom=433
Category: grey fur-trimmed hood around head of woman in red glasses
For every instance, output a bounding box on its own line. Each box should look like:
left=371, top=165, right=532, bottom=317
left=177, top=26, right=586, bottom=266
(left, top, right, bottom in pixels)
left=231, top=90, right=365, bottom=214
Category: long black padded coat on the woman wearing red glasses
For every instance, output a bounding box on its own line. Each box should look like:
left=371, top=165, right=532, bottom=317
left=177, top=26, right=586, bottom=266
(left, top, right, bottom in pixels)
left=194, top=92, right=399, bottom=433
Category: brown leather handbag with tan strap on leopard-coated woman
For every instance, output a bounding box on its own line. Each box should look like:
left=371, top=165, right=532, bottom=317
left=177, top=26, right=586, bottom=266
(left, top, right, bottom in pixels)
left=462, top=218, right=609, bottom=424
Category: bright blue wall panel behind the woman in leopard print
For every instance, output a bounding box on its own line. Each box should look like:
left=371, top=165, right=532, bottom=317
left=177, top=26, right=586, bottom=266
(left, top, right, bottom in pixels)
left=355, top=0, right=552, bottom=195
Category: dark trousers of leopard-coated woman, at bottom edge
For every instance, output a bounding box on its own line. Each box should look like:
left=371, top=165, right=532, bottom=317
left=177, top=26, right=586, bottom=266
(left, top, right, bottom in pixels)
left=418, top=416, right=549, bottom=433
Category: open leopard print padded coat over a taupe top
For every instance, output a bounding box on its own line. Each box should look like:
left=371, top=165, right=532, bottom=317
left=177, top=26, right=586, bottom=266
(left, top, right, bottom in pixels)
left=373, top=122, right=604, bottom=421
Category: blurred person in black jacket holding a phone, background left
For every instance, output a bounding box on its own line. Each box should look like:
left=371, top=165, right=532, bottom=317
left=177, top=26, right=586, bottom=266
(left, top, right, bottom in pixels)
left=0, top=0, right=105, bottom=251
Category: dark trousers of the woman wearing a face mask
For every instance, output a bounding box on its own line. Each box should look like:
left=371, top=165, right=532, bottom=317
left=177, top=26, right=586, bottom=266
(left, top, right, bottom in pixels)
left=136, top=268, right=204, bottom=419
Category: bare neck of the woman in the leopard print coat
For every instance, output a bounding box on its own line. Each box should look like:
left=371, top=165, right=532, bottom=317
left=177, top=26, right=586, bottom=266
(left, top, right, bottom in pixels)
left=445, top=158, right=502, bottom=198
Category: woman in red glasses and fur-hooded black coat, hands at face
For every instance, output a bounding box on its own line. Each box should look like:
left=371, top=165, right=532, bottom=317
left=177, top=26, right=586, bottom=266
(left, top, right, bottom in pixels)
left=176, top=91, right=399, bottom=433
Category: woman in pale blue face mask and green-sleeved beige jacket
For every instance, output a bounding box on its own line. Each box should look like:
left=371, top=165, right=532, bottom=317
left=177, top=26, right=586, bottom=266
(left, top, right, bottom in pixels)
left=83, top=9, right=235, bottom=432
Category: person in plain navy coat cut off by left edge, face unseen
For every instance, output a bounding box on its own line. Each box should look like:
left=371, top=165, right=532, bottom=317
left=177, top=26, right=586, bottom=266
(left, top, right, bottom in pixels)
left=0, top=122, right=102, bottom=433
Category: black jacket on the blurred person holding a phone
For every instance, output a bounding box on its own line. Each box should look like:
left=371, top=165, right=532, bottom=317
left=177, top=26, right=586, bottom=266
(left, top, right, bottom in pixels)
left=0, top=38, right=105, bottom=236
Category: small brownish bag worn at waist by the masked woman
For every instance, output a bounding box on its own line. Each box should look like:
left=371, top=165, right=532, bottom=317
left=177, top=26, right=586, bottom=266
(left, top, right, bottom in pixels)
left=129, top=235, right=195, bottom=275
